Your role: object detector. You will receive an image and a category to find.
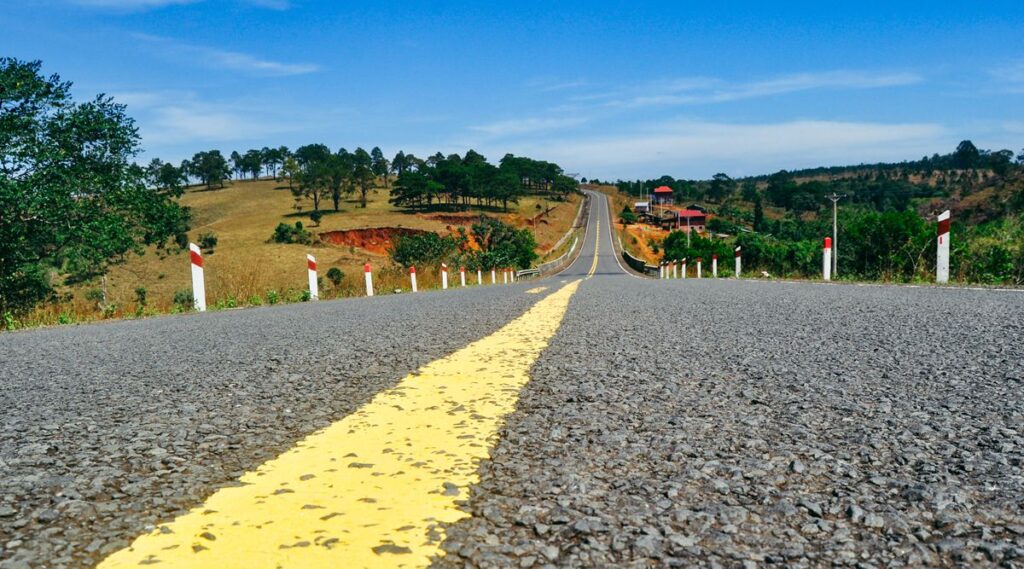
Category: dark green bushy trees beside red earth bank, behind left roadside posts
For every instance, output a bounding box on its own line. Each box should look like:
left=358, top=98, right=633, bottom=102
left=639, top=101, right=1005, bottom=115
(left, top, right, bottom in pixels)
left=390, top=217, right=537, bottom=270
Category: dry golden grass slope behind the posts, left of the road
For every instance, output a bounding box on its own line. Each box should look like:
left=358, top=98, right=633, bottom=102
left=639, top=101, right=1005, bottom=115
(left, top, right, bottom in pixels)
left=25, top=180, right=580, bottom=324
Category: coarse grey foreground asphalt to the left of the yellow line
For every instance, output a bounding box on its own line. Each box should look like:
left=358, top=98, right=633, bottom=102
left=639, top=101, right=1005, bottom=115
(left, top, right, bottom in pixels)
left=0, top=287, right=538, bottom=569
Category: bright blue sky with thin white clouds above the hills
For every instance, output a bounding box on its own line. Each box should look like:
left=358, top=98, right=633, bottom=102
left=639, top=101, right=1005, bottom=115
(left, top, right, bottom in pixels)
left=8, top=0, right=1024, bottom=179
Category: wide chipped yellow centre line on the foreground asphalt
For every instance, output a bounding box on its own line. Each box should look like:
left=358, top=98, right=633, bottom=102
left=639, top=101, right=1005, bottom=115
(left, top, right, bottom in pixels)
left=99, top=280, right=580, bottom=568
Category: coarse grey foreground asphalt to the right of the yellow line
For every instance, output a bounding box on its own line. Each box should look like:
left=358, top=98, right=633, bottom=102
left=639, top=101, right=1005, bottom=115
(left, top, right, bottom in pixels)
left=435, top=276, right=1024, bottom=567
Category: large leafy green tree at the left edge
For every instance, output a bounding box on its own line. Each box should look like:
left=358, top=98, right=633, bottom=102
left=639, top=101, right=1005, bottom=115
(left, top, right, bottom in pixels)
left=0, top=57, right=188, bottom=313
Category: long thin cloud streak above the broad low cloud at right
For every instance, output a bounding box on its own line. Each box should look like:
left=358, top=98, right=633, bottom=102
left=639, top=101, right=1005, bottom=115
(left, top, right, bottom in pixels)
left=593, top=71, right=923, bottom=107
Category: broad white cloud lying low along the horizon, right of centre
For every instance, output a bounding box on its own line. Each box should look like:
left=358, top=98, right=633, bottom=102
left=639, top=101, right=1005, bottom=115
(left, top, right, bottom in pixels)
left=488, top=121, right=955, bottom=178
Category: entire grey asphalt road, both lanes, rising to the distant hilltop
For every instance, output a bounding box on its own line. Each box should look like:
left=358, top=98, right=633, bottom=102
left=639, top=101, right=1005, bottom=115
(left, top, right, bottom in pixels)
left=0, top=190, right=1024, bottom=568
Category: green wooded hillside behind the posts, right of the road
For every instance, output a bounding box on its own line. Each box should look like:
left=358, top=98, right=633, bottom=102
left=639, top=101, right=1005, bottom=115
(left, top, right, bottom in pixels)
left=606, top=141, right=1024, bottom=285
